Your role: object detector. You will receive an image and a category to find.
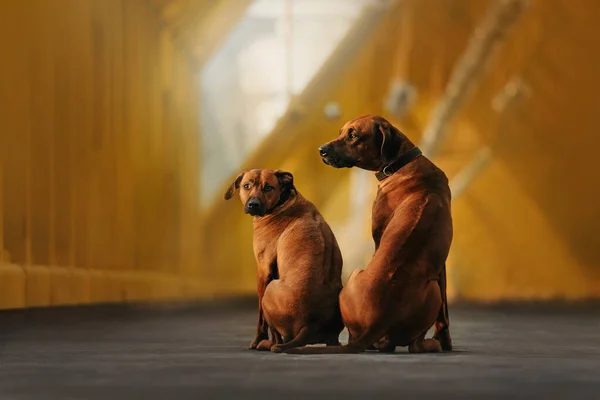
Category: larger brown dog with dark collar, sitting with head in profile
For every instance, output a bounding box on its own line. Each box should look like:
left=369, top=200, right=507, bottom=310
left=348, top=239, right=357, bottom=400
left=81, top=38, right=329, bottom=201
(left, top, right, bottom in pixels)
left=289, top=115, right=452, bottom=354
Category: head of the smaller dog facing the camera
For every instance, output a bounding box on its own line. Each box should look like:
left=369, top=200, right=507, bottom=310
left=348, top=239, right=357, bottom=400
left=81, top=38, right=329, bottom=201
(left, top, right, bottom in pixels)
left=224, top=169, right=295, bottom=217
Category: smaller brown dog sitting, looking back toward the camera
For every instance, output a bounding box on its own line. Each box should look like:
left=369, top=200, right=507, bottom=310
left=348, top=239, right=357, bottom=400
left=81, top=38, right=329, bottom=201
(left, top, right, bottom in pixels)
left=225, top=169, right=344, bottom=352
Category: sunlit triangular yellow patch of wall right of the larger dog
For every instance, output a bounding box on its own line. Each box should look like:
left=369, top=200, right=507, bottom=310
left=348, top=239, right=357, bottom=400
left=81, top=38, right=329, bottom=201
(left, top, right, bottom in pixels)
left=449, top=162, right=594, bottom=301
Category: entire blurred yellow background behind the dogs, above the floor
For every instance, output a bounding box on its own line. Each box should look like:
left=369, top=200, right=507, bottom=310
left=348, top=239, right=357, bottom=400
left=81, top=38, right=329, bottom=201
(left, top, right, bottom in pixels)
left=0, top=0, right=600, bottom=309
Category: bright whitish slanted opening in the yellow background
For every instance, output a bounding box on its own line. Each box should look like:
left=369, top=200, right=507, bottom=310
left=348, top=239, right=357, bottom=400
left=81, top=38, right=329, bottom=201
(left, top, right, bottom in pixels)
left=201, top=0, right=375, bottom=205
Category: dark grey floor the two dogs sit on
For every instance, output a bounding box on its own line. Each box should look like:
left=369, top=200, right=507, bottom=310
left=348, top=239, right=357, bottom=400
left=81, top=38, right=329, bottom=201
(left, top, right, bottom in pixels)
left=0, top=305, right=600, bottom=400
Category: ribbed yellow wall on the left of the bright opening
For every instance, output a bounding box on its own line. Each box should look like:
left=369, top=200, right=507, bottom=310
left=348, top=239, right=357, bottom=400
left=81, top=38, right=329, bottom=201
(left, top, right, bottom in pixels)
left=0, top=0, right=220, bottom=308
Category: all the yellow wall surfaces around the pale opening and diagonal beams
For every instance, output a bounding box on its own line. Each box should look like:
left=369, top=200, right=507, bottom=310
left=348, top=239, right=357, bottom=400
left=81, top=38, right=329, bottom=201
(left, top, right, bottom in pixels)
left=0, top=0, right=600, bottom=308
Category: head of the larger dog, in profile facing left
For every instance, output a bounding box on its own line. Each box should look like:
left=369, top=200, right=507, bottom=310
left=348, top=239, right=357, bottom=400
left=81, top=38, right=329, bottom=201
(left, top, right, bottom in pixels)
left=319, top=115, right=414, bottom=171
